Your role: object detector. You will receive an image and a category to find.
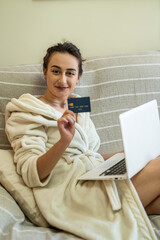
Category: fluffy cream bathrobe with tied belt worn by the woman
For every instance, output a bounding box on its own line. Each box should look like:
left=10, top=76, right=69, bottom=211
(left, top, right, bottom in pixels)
left=6, top=94, right=156, bottom=240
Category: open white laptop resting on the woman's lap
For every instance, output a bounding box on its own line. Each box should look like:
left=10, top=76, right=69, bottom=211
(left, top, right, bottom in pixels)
left=78, top=100, right=160, bottom=180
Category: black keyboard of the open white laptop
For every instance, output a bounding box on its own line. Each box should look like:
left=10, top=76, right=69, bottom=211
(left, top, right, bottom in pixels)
left=99, top=158, right=126, bottom=176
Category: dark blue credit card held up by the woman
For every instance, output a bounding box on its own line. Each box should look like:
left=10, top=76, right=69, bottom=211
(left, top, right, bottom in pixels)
left=68, top=97, right=91, bottom=113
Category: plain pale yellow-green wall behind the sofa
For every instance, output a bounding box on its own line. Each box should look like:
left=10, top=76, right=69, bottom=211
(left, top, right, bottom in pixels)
left=0, top=0, right=160, bottom=65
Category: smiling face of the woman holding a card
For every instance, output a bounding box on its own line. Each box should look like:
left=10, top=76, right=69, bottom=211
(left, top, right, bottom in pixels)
left=43, top=52, right=79, bottom=100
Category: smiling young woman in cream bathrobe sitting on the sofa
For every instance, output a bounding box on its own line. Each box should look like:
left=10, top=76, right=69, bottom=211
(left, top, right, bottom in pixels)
left=6, top=42, right=160, bottom=240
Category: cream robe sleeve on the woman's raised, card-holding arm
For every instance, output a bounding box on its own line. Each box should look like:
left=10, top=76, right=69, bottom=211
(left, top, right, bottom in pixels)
left=6, top=112, right=51, bottom=187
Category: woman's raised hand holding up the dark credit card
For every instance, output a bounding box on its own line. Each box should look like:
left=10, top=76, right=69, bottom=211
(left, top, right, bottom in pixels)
left=57, top=110, right=76, bottom=145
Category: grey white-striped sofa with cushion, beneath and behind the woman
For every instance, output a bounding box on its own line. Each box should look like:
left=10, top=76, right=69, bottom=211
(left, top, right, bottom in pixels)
left=0, top=51, right=160, bottom=240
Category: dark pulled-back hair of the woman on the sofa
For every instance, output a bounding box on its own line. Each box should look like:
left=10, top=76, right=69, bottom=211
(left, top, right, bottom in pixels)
left=43, top=42, right=84, bottom=76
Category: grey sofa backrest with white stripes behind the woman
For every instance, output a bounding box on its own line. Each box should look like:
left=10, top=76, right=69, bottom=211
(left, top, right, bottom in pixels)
left=0, top=51, right=160, bottom=153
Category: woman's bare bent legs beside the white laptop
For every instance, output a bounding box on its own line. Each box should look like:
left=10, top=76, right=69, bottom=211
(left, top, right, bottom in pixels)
left=131, top=158, right=160, bottom=214
